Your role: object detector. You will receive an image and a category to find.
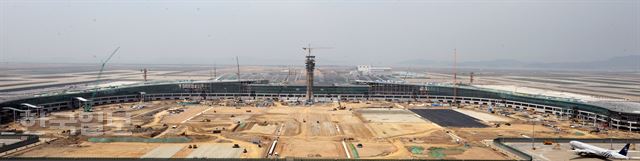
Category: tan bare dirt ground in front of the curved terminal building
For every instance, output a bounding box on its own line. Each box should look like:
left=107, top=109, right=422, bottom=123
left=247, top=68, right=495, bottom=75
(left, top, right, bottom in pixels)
left=10, top=101, right=636, bottom=160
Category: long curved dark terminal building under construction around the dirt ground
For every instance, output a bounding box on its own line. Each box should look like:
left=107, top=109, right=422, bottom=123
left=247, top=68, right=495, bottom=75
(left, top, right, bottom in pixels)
left=0, top=80, right=640, bottom=131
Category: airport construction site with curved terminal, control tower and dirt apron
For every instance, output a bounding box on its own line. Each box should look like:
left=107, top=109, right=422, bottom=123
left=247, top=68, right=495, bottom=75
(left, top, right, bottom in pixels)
left=0, top=52, right=640, bottom=161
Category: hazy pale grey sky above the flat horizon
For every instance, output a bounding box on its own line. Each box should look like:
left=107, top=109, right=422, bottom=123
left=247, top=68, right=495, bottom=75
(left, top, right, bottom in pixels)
left=0, top=0, right=640, bottom=65
